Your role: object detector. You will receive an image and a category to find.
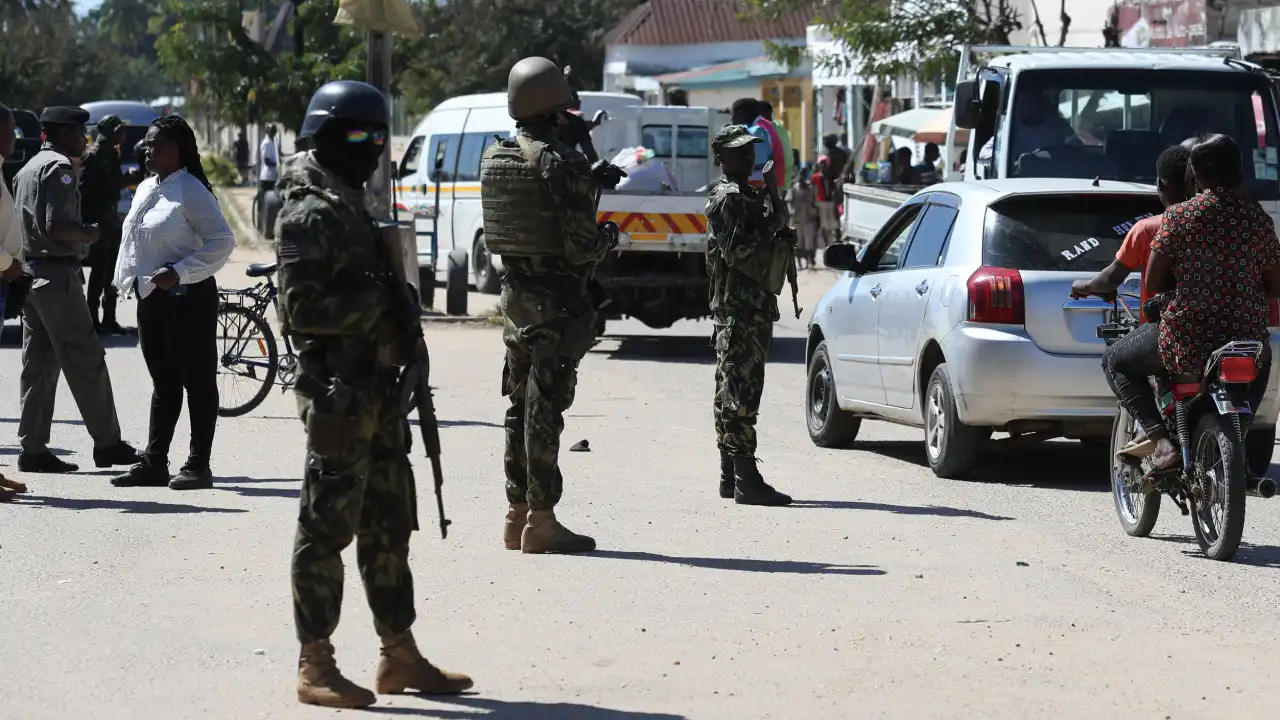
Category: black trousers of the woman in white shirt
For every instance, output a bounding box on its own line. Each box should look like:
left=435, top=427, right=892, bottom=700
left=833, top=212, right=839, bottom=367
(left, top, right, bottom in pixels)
left=138, top=278, right=218, bottom=469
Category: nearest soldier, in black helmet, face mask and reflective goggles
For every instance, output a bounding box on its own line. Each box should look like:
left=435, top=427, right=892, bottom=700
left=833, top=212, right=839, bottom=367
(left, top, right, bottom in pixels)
left=276, top=81, right=471, bottom=707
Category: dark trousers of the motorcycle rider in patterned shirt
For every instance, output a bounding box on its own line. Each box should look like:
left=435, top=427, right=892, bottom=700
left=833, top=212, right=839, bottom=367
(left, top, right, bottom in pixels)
left=1102, top=323, right=1271, bottom=435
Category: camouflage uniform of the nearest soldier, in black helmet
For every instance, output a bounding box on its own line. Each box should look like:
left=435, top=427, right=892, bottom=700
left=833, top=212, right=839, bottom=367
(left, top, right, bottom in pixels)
left=276, top=152, right=417, bottom=644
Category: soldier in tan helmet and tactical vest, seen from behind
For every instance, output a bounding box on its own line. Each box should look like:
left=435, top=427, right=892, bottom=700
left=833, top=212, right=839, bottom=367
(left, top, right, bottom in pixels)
left=480, top=58, right=623, bottom=553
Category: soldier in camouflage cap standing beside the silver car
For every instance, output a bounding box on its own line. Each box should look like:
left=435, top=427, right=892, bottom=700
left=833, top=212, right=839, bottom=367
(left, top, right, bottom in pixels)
left=707, top=126, right=792, bottom=506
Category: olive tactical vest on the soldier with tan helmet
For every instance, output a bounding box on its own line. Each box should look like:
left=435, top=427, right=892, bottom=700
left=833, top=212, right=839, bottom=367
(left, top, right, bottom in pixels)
left=480, top=135, right=598, bottom=258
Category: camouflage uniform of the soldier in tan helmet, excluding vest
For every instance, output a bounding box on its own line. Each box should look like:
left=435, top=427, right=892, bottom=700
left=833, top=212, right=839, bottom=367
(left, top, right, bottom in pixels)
left=481, top=129, right=609, bottom=510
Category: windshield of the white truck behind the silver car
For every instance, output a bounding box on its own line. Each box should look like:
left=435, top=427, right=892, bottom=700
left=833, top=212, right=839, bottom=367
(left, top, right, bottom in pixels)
left=1007, top=68, right=1280, bottom=200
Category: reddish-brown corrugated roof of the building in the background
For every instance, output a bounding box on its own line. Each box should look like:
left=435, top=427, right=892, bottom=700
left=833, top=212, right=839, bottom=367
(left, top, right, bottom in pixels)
left=604, top=0, right=813, bottom=45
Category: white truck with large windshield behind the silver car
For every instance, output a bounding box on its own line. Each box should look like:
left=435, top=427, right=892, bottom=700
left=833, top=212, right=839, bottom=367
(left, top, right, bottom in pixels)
left=844, top=46, right=1280, bottom=242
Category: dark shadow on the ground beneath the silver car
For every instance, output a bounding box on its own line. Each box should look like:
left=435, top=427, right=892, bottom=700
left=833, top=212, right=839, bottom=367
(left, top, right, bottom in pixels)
left=850, top=439, right=1111, bottom=492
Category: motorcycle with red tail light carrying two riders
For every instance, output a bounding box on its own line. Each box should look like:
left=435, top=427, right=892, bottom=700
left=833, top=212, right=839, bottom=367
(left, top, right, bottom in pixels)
left=1097, top=292, right=1276, bottom=560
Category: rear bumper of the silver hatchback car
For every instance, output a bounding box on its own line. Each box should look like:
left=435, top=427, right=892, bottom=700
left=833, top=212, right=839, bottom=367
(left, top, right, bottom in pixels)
left=942, top=323, right=1280, bottom=428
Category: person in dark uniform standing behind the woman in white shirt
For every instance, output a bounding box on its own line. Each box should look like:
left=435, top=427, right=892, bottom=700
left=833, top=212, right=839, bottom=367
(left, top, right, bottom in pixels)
left=79, top=115, right=124, bottom=334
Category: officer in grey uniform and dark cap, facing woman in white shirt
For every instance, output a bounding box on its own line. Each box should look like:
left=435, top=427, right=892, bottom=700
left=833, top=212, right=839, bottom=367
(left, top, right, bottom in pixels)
left=14, top=108, right=138, bottom=473
